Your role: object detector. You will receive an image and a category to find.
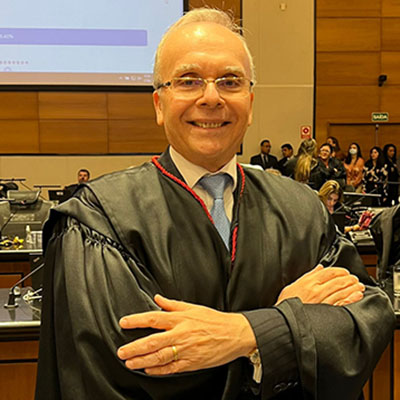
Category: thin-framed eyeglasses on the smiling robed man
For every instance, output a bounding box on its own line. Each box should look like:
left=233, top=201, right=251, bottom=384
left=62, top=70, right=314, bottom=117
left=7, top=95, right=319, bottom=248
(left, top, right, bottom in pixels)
left=156, top=76, right=254, bottom=97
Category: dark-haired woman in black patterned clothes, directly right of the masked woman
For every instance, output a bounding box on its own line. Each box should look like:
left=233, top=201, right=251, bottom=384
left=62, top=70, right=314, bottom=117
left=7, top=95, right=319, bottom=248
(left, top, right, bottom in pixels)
left=363, top=146, right=388, bottom=206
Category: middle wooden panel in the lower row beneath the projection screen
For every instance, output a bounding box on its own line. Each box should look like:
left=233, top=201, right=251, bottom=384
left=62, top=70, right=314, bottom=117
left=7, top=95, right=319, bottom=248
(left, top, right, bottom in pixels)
left=40, top=120, right=108, bottom=154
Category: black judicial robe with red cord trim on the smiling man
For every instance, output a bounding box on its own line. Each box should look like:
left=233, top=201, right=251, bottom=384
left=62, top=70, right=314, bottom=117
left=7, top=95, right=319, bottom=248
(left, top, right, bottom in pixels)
left=36, top=155, right=394, bottom=400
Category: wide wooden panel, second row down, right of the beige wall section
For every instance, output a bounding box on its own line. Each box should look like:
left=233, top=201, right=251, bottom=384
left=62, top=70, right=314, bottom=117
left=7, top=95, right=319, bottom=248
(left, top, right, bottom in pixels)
left=317, top=18, right=380, bottom=51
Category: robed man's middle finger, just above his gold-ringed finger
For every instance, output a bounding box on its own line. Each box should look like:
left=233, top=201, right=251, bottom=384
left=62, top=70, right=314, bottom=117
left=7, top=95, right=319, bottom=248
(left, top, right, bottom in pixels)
left=117, top=332, right=172, bottom=360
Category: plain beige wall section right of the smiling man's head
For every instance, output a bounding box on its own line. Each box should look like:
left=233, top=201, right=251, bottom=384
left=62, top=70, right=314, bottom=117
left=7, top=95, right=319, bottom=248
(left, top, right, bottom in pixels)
left=240, top=0, right=314, bottom=162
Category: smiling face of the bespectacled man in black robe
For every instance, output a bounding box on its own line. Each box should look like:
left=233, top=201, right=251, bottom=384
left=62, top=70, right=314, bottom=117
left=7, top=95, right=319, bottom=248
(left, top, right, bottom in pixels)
left=153, top=22, right=253, bottom=171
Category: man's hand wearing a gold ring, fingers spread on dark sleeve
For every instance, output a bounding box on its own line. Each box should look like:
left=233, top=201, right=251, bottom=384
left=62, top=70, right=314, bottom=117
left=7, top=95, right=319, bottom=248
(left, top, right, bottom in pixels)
left=117, top=295, right=256, bottom=375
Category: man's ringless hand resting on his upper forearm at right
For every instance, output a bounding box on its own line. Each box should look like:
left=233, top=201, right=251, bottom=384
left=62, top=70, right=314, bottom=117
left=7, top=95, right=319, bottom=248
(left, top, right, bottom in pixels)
left=276, top=264, right=365, bottom=306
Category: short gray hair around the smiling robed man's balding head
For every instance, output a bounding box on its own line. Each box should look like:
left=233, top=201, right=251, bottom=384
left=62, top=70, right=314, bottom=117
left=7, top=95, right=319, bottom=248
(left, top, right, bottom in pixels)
left=153, top=7, right=255, bottom=89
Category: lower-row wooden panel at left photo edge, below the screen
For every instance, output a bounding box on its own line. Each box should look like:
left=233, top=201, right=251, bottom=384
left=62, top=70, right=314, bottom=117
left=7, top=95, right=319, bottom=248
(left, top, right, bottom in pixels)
left=0, top=119, right=39, bottom=154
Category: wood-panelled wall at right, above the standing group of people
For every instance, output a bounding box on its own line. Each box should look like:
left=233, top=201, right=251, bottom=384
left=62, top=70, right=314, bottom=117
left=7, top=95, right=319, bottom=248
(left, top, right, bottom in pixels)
left=316, top=0, right=400, bottom=154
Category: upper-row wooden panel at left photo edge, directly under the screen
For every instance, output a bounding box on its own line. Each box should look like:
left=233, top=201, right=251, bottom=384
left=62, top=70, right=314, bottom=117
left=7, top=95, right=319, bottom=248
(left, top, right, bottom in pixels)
left=0, top=92, right=38, bottom=119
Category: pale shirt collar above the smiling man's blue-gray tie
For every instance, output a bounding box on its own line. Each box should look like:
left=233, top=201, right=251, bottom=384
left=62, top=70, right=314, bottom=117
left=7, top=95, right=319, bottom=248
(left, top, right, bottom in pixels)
left=169, top=146, right=237, bottom=192
